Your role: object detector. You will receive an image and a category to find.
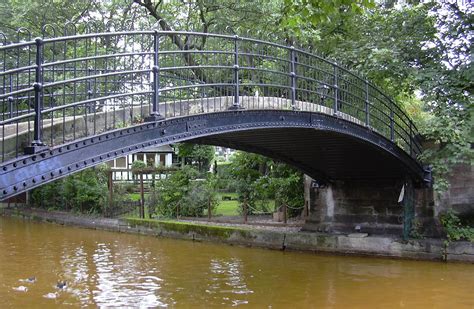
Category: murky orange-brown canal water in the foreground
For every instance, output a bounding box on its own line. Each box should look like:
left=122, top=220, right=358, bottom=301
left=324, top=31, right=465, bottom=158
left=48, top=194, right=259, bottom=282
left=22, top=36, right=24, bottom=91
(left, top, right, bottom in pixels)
left=0, top=217, right=474, bottom=308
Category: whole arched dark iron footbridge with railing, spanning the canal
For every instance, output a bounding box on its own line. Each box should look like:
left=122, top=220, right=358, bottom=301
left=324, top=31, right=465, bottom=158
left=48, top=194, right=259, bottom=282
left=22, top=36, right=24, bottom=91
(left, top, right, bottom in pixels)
left=0, top=26, right=427, bottom=200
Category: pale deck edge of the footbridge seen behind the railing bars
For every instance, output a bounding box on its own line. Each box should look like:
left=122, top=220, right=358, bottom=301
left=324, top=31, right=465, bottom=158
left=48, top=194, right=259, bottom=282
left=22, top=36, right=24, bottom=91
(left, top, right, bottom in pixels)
left=0, top=96, right=386, bottom=160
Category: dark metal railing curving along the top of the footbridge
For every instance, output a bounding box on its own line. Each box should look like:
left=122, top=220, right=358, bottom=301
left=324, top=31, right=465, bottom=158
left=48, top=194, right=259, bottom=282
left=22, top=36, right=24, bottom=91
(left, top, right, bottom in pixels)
left=0, top=31, right=421, bottom=162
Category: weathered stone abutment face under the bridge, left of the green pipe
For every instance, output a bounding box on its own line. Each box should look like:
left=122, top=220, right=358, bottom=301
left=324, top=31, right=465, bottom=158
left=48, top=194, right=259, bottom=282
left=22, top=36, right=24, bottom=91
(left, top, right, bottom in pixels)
left=304, top=181, right=412, bottom=235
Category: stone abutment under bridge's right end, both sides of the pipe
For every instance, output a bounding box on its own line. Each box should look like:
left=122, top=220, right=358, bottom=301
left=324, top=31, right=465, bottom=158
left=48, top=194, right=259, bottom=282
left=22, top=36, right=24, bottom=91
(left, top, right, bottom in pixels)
left=303, top=180, right=440, bottom=236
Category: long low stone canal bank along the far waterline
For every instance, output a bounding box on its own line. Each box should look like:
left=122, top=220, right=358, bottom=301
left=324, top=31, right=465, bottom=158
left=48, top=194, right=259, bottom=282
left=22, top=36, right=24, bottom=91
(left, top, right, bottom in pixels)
left=0, top=208, right=474, bottom=263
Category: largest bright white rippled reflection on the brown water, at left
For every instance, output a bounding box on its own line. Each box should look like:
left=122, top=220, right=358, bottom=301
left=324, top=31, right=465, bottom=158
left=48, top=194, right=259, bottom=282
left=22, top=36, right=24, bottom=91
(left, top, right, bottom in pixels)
left=56, top=243, right=165, bottom=308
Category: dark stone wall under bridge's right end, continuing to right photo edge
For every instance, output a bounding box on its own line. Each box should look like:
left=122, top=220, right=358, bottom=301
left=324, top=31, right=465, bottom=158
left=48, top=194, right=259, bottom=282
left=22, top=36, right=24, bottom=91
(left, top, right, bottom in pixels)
left=304, top=164, right=474, bottom=238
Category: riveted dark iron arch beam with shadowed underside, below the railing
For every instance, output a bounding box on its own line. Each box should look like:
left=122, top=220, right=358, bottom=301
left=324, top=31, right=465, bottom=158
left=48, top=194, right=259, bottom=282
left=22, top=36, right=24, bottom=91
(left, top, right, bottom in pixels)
left=0, top=110, right=424, bottom=199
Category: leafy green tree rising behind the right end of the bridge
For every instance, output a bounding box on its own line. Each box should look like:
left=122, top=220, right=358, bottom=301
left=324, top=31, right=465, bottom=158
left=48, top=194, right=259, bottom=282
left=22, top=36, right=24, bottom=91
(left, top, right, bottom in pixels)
left=280, top=1, right=474, bottom=191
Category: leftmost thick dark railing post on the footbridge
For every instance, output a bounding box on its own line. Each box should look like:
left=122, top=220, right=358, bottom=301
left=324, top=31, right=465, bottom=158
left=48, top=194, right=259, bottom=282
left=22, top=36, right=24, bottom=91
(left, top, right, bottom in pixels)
left=25, top=38, right=47, bottom=154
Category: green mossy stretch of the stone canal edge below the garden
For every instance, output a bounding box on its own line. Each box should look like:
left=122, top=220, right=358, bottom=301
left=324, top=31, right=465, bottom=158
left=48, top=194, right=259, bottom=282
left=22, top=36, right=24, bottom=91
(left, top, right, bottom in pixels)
left=125, top=218, right=252, bottom=239
